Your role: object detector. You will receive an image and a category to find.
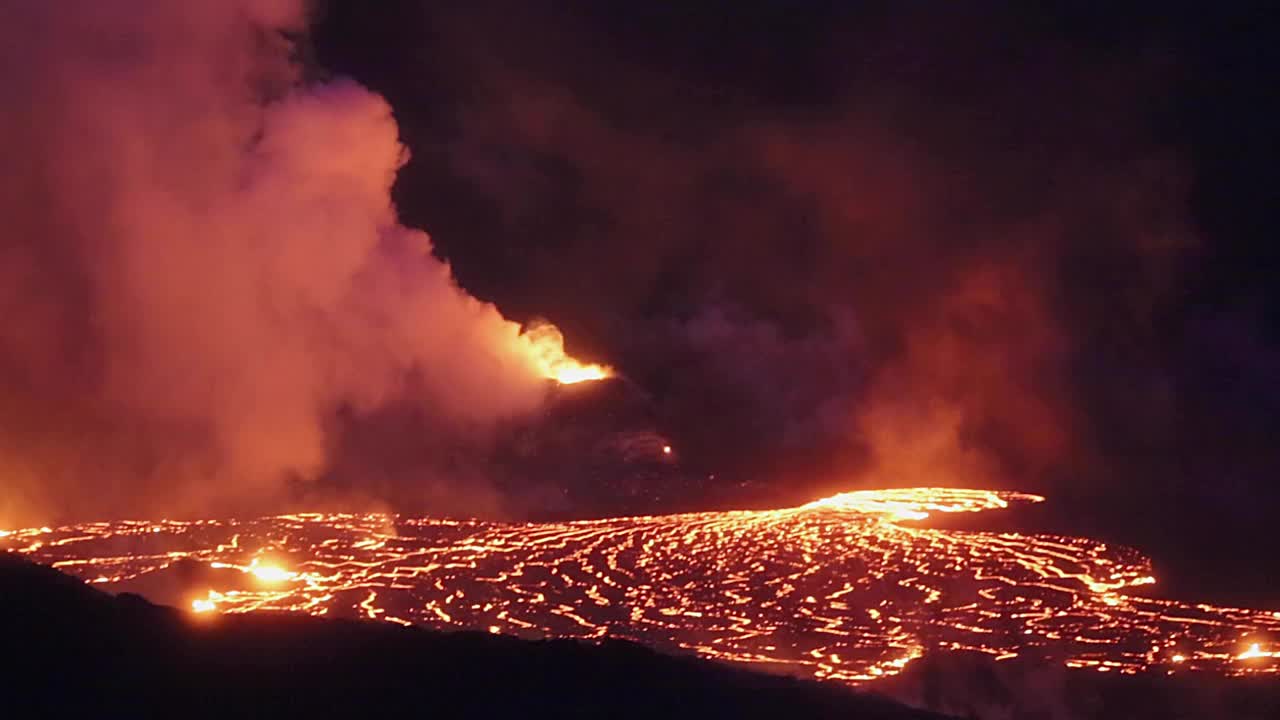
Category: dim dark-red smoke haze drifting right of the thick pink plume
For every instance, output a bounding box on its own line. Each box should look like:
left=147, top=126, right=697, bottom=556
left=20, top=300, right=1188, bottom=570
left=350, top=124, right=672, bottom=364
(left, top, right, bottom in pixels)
left=314, top=3, right=1192, bottom=493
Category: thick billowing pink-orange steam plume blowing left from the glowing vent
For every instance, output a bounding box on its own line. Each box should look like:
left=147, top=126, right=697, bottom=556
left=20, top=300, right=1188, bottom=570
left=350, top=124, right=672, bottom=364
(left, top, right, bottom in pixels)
left=0, top=0, right=581, bottom=525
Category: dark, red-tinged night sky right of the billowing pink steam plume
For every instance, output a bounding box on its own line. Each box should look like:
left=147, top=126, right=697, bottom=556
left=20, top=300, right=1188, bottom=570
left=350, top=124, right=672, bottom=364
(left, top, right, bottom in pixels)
left=305, top=0, right=1280, bottom=596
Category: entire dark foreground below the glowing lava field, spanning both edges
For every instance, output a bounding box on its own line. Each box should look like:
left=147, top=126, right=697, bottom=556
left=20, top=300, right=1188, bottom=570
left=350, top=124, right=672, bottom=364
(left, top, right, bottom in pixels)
left=0, top=555, right=1280, bottom=720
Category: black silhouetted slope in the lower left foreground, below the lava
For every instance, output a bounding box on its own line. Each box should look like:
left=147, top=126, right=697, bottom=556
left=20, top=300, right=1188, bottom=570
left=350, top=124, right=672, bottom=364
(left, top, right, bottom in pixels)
left=0, top=556, right=940, bottom=720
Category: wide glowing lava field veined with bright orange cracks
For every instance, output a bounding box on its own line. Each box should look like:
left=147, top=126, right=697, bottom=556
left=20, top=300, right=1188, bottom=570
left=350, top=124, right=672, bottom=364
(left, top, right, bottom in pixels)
left=0, top=488, right=1280, bottom=684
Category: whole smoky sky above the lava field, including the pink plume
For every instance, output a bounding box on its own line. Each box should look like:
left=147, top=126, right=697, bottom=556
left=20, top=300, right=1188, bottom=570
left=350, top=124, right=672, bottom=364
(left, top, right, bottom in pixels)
left=0, top=0, right=1280, bottom=606
